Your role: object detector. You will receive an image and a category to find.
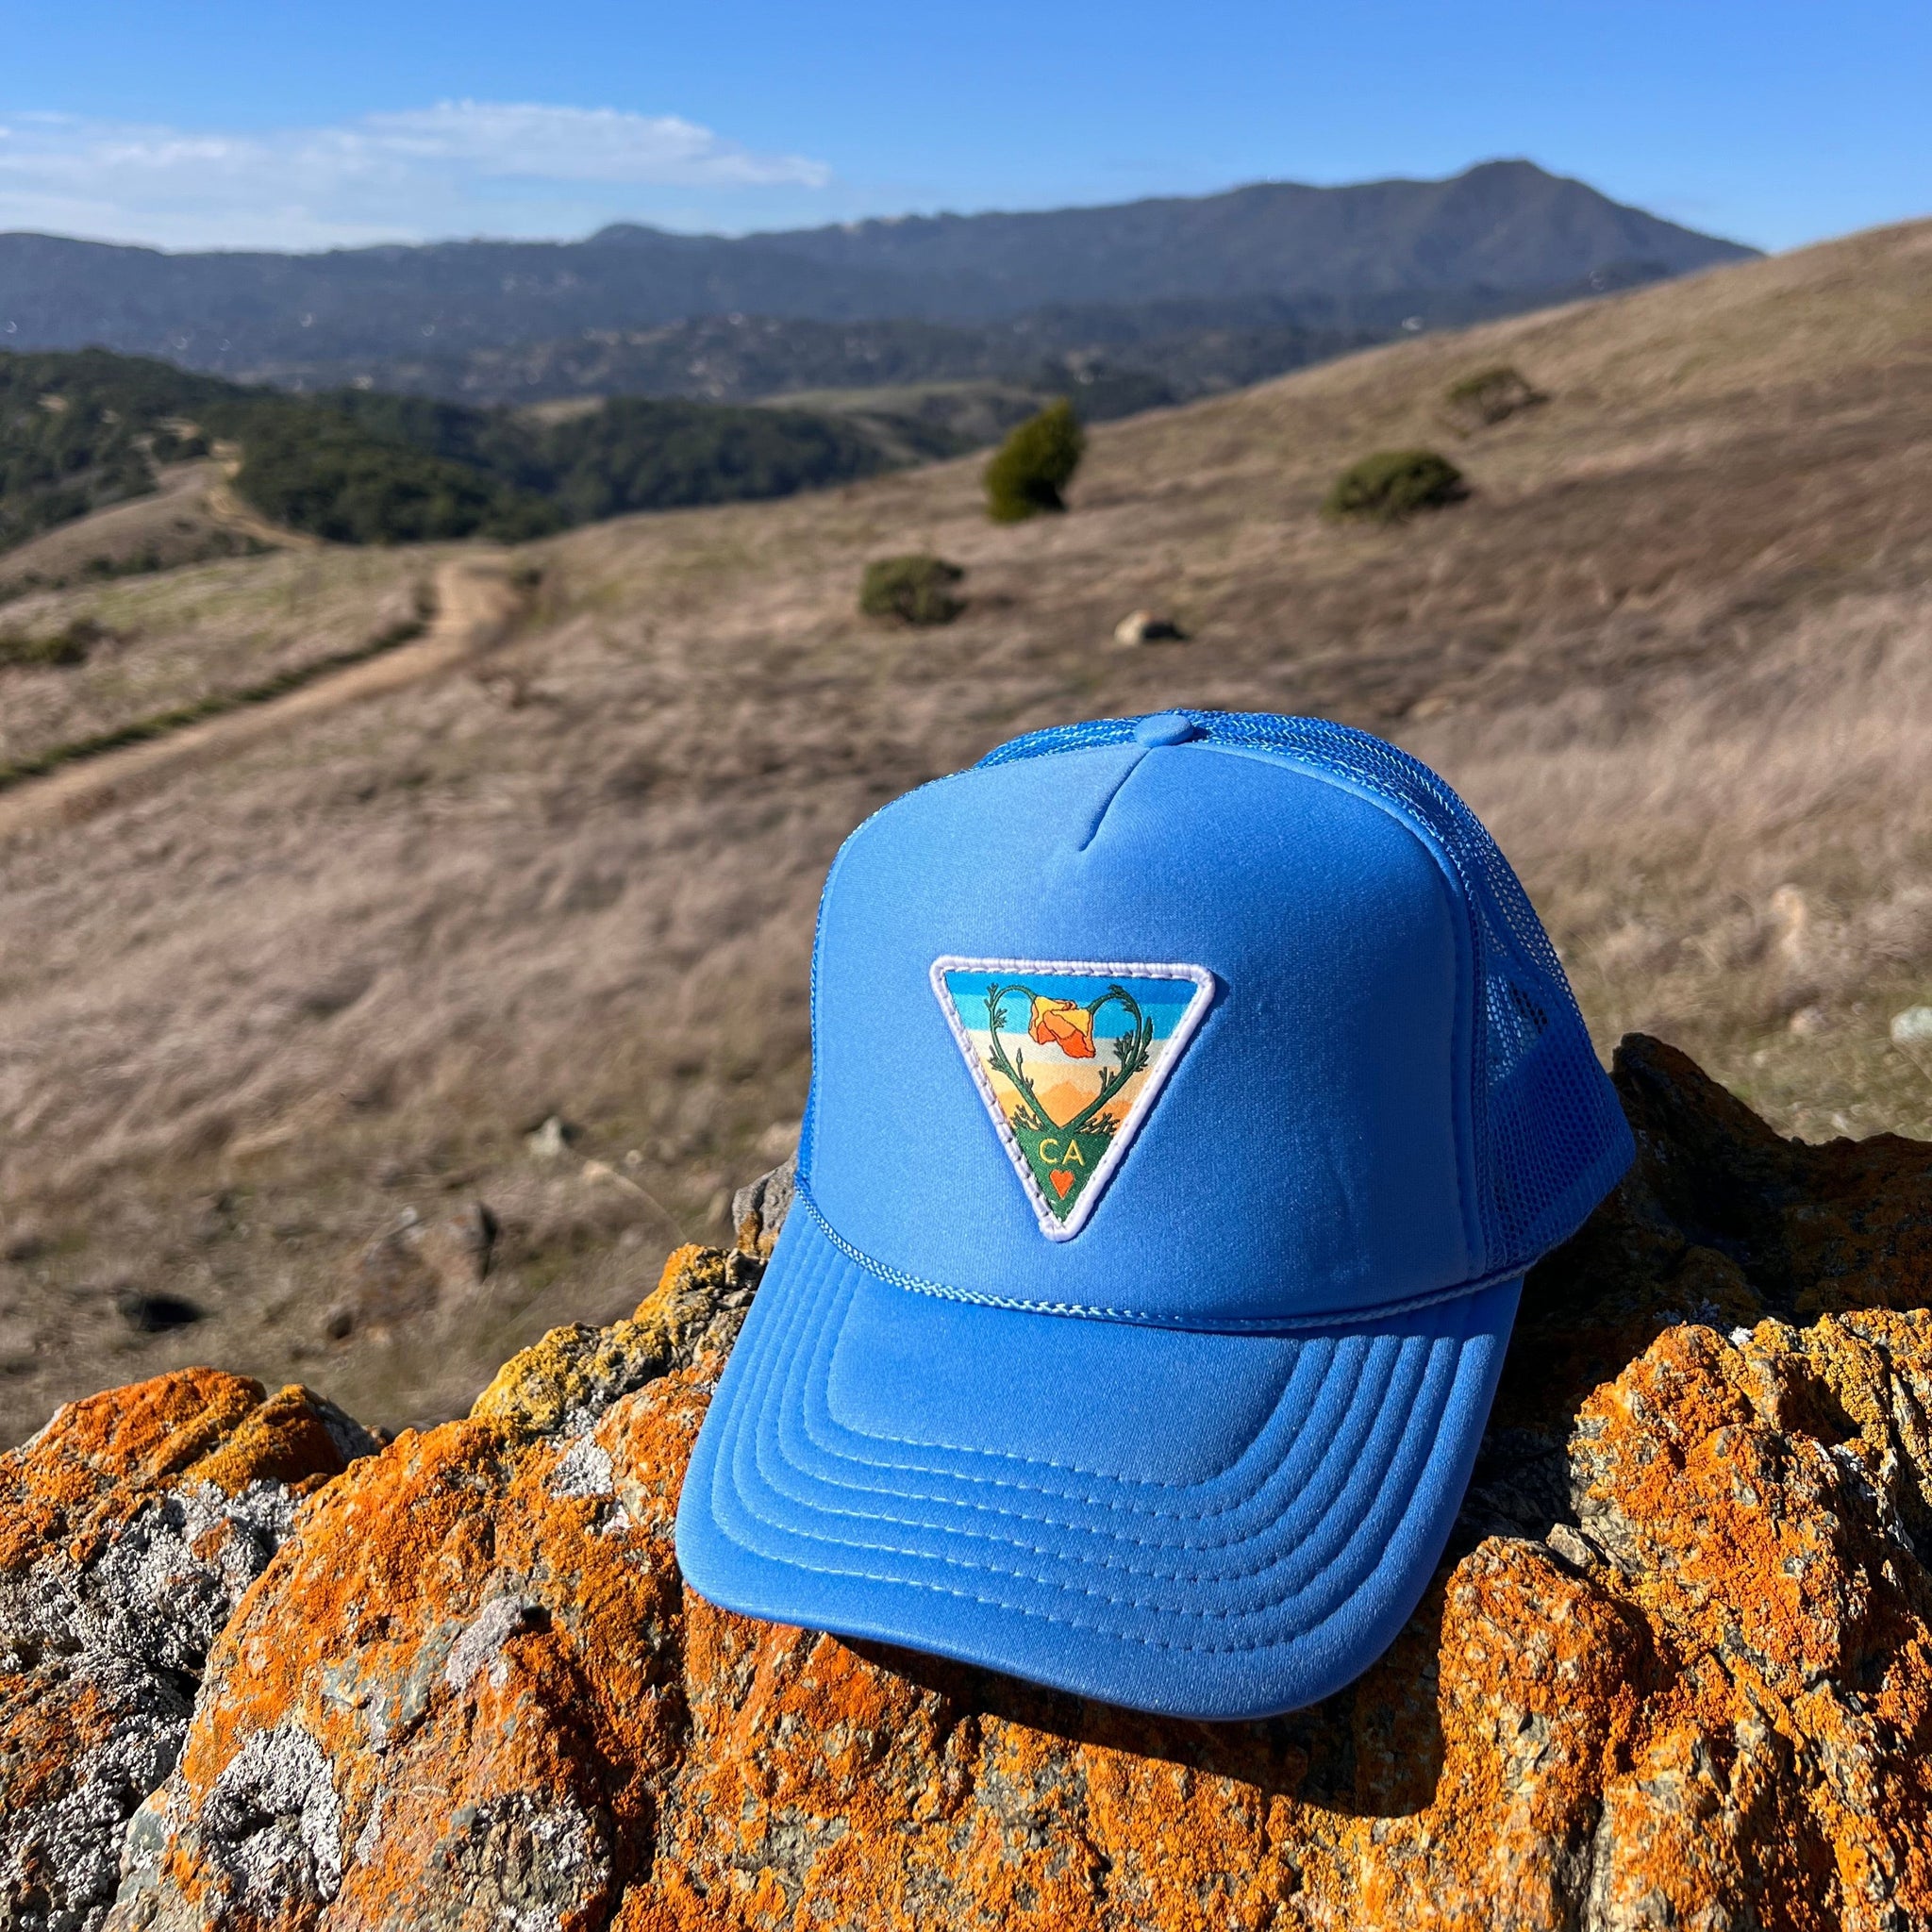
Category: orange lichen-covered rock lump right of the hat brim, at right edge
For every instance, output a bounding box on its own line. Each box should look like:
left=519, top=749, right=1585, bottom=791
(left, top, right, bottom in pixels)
left=1571, top=1314, right=1932, bottom=1932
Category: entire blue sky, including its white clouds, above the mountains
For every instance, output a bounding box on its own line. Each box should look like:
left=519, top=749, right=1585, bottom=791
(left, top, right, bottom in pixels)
left=0, top=0, right=1932, bottom=247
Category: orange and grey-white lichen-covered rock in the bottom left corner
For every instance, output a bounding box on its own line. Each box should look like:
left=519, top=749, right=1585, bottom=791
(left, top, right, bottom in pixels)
left=0, top=1368, right=375, bottom=1932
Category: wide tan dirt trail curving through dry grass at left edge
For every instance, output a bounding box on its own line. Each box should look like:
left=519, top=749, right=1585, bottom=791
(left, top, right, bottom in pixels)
left=0, top=557, right=520, bottom=839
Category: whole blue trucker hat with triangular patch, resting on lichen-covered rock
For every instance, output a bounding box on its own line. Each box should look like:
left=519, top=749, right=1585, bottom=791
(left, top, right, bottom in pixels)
left=678, top=711, right=1633, bottom=1718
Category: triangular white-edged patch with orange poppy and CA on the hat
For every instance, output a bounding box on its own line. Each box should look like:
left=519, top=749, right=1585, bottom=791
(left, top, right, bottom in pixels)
left=933, top=957, right=1213, bottom=1241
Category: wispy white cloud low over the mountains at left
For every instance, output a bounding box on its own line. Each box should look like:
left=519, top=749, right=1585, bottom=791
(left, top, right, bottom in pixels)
left=0, top=100, right=831, bottom=249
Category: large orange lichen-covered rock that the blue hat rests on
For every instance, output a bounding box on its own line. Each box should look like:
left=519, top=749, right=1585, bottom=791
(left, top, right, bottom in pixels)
left=114, top=1316, right=1932, bottom=1932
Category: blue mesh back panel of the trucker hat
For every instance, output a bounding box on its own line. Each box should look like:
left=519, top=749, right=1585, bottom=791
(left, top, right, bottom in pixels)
left=979, top=711, right=1635, bottom=1274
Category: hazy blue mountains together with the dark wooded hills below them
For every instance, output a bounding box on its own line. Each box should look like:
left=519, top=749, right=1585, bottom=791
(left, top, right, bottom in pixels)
left=0, top=162, right=1750, bottom=572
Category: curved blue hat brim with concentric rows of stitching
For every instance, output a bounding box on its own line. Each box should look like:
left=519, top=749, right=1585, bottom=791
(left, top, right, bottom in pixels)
left=678, top=1206, right=1521, bottom=1720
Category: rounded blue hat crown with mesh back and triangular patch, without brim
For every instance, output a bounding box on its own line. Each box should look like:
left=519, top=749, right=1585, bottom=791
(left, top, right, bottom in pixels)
left=800, top=711, right=1628, bottom=1329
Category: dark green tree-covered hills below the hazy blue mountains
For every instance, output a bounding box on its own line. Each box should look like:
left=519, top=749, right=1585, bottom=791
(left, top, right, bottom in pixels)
left=0, top=350, right=904, bottom=553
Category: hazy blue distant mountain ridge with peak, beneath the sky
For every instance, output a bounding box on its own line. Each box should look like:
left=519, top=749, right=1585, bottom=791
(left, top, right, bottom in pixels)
left=0, top=160, right=1755, bottom=376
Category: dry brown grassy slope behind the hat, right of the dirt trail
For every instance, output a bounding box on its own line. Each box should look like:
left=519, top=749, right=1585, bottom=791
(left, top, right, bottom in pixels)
left=0, top=225, right=1932, bottom=1434
